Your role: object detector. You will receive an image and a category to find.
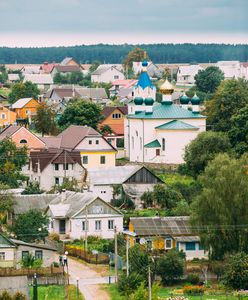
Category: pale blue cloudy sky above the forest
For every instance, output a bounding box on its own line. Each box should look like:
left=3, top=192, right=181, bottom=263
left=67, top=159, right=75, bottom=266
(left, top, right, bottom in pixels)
left=0, top=0, right=248, bottom=47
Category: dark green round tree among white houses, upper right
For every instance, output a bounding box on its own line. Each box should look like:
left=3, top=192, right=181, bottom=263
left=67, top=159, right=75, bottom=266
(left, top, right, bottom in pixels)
left=195, top=66, right=225, bottom=93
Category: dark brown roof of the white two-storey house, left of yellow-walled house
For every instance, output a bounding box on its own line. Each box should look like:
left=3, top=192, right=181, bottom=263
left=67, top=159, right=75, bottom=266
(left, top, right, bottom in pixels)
left=30, top=149, right=82, bottom=172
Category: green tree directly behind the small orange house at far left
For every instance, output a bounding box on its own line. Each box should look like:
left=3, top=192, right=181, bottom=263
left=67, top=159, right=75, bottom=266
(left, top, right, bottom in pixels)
left=9, top=81, right=40, bottom=104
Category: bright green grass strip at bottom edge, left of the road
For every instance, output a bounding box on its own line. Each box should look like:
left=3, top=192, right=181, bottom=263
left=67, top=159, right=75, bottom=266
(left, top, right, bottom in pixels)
left=30, top=285, right=84, bottom=300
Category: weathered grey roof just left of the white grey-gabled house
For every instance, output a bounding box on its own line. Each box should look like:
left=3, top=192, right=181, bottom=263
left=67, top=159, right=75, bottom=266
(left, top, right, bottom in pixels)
left=13, top=194, right=58, bottom=215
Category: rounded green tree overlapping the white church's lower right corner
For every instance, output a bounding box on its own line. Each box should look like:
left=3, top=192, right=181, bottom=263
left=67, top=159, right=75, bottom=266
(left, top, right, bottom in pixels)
left=184, top=131, right=231, bottom=177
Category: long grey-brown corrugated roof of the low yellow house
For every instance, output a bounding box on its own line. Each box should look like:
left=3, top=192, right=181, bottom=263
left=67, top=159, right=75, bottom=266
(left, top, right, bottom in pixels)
left=130, top=216, right=191, bottom=236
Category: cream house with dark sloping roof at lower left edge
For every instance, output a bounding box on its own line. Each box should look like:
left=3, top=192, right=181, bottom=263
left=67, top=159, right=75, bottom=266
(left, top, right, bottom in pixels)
left=0, top=233, right=56, bottom=268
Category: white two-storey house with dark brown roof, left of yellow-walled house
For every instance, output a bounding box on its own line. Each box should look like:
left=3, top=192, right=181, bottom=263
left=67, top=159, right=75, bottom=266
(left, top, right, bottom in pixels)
left=23, top=149, right=85, bottom=191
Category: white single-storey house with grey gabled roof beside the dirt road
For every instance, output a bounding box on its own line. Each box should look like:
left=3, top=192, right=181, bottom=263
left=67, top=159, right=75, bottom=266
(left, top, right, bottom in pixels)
left=46, top=191, right=123, bottom=239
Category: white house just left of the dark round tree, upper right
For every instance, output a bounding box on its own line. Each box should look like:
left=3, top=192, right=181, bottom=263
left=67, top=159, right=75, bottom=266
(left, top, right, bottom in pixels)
left=177, top=65, right=203, bottom=85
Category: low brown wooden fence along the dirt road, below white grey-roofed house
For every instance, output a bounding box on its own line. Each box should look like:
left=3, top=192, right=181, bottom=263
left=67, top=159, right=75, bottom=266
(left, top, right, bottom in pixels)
left=65, top=245, right=109, bottom=264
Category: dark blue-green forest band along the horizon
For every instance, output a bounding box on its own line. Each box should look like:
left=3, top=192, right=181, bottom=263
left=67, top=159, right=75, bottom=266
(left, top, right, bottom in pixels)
left=0, top=44, right=248, bottom=64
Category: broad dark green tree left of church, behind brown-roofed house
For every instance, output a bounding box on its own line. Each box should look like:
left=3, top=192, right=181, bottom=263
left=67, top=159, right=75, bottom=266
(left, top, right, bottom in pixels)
left=58, top=98, right=102, bottom=129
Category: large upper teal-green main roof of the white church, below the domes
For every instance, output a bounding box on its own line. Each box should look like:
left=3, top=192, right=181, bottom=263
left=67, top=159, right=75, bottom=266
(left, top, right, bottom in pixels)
left=127, top=103, right=206, bottom=119
